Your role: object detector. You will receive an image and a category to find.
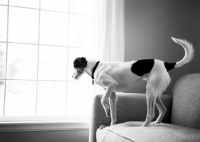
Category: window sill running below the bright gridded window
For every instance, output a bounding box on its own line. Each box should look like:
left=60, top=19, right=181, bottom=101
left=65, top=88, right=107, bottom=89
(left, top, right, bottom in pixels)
left=0, top=117, right=89, bottom=133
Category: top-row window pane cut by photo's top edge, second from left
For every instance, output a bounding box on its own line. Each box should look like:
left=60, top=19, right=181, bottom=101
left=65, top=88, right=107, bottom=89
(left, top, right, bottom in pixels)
left=9, top=0, right=39, bottom=8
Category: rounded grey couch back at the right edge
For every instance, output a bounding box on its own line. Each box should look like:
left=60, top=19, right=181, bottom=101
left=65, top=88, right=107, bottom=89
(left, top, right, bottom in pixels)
left=171, top=73, right=200, bottom=129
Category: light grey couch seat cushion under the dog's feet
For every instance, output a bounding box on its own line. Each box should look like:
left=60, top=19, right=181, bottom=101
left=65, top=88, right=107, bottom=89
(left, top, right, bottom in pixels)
left=96, top=121, right=200, bottom=142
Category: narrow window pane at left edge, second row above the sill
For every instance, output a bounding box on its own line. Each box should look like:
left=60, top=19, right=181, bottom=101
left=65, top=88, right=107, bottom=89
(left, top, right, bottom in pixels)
left=0, top=43, right=6, bottom=79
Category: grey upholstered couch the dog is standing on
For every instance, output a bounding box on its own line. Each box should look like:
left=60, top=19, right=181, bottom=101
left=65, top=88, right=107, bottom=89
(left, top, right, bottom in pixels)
left=89, top=73, right=200, bottom=142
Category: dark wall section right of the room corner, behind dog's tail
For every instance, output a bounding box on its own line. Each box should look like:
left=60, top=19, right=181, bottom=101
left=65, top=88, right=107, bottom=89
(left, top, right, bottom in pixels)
left=177, top=0, right=200, bottom=78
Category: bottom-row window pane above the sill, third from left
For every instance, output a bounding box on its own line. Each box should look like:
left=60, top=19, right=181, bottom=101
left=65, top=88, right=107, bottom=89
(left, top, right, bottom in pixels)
left=37, top=81, right=66, bottom=116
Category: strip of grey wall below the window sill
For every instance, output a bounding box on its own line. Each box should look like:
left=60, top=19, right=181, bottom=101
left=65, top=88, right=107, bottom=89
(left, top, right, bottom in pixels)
left=0, top=130, right=89, bottom=142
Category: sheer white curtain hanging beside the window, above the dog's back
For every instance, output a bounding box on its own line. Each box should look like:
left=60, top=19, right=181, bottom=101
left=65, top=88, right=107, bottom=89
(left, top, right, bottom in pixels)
left=94, top=0, right=125, bottom=62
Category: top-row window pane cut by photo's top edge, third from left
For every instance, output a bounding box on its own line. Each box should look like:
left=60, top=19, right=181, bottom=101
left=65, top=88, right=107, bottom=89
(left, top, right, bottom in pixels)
left=41, top=0, right=68, bottom=12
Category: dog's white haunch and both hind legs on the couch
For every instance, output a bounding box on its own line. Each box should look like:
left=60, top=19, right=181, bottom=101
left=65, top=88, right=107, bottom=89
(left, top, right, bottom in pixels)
left=142, top=70, right=170, bottom=126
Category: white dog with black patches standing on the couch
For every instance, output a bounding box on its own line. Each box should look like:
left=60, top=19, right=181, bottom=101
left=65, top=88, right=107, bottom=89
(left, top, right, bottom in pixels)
left=72, top=37, right=194, bottom=127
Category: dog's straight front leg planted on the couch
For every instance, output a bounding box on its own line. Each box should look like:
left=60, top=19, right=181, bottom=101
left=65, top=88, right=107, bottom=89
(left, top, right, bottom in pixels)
left=109, top=92, right=117, bottom=125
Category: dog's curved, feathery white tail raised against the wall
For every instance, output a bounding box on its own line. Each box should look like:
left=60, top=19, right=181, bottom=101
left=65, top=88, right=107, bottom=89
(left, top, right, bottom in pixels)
left=171, top=37, right=194, bottom=68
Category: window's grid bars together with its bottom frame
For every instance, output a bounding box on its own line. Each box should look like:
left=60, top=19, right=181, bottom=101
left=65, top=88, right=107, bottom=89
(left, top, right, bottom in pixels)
left=0, top=0, right=94, bottom=123
